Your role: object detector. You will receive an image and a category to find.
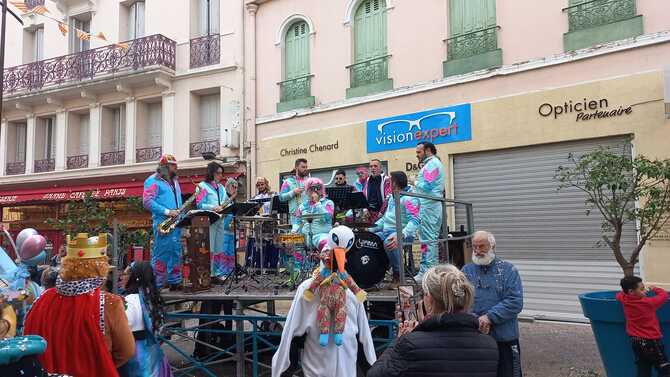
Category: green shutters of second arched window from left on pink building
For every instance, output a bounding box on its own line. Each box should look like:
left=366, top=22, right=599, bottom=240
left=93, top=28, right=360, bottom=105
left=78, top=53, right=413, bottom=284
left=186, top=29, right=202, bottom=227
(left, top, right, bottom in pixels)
left=354, top=0, right=387, bottom=62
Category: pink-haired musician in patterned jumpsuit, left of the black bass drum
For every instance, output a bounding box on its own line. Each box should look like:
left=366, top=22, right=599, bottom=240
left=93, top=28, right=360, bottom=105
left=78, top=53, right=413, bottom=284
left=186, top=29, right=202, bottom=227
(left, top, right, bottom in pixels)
left=292, top=178, right=335, bottom=251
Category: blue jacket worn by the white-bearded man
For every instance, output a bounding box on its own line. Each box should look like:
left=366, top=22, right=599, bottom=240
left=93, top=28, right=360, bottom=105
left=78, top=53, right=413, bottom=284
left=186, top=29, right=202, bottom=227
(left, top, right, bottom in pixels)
left=463, top=258, right=523, bottom=342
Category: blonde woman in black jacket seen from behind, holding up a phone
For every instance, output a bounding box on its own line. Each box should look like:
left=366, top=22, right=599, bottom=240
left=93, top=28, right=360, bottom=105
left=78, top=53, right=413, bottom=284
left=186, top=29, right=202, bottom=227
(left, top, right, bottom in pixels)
left=367, top=264, right=498, bottom=377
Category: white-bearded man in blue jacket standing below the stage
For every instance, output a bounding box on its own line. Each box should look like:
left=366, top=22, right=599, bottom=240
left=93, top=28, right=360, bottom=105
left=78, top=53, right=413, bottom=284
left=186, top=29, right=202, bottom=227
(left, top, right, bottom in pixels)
left=463, top=231, right=523, bottom=377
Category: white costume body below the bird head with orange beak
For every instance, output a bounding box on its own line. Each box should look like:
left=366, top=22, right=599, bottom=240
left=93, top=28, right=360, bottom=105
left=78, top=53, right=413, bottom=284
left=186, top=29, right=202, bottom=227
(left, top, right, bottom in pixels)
left=272, top=278, right=377, bottom=377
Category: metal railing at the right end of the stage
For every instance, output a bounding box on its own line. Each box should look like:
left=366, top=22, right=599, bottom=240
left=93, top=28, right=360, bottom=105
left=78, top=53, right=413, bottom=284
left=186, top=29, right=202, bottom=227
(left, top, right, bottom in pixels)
left=393, top=190, right=475, bottom=284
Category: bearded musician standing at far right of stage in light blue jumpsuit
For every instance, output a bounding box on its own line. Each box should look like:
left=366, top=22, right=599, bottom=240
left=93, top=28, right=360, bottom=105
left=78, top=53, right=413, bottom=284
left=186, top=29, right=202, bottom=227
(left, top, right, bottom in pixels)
left=414, top=142, right=445, bottom=282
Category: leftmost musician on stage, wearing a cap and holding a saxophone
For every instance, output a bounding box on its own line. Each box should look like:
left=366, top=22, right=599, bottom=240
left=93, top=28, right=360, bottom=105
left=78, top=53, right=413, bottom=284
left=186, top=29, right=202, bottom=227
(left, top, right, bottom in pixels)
left=142, top=154, right=182, bottom=290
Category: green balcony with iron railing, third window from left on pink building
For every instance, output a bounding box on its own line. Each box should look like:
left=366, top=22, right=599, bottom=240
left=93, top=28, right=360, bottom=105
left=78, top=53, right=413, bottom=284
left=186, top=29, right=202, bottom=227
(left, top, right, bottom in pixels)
left=442, top=26, right=502, bottom=77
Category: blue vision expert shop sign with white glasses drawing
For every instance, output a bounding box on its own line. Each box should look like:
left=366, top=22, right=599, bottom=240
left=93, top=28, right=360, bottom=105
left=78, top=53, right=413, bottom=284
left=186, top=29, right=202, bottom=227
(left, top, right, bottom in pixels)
left=366, top=103, right=472, bottom=153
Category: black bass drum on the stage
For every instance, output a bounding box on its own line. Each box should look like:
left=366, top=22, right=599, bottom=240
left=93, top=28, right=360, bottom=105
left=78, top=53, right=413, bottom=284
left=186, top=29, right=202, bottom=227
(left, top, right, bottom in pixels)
left=345, top=231, right=389, bottom=288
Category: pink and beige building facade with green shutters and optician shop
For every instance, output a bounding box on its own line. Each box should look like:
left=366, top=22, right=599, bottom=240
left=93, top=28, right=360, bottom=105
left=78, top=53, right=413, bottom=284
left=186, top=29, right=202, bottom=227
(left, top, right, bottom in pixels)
left=246, top=0, right=670, bottom=319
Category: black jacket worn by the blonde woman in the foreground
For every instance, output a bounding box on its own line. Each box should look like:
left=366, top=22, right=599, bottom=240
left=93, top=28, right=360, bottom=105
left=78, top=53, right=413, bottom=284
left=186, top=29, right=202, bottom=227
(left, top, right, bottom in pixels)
left=367, top=313, right=498, bottom=377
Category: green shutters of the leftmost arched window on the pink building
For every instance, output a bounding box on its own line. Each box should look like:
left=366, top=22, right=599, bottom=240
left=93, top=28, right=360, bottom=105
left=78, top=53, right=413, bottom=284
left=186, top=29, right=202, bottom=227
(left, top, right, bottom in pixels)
left=284, top=21, right=309, bottom=80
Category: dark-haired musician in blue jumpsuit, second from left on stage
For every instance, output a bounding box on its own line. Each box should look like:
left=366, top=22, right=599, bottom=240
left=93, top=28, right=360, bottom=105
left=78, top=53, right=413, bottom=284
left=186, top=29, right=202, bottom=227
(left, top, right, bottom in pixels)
left=195, top=162, right=237, bottom=281
